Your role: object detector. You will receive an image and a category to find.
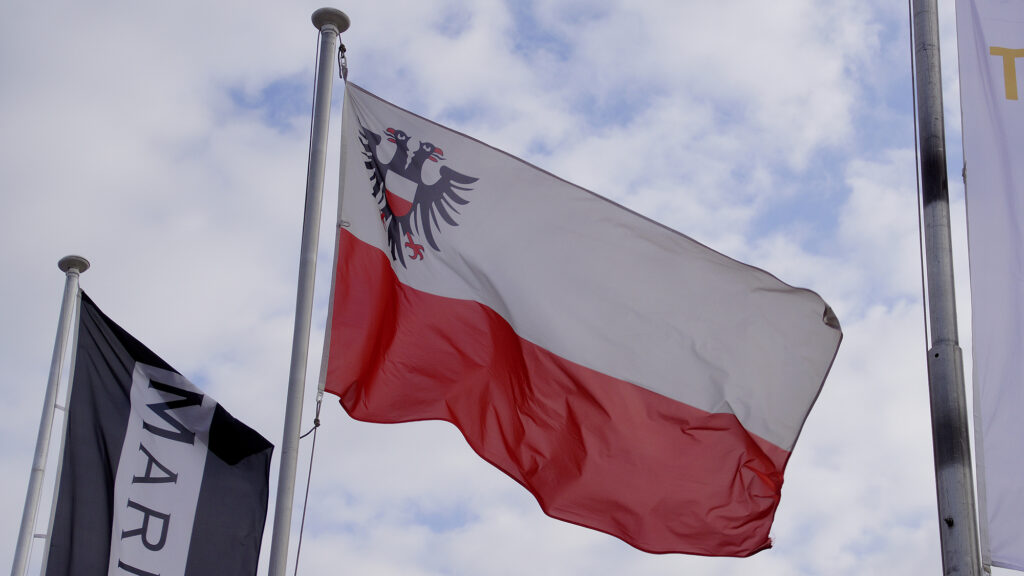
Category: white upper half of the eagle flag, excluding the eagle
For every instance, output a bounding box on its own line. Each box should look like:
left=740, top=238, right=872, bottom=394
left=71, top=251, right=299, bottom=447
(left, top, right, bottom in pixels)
left=339, top=84, right=842, bottom=450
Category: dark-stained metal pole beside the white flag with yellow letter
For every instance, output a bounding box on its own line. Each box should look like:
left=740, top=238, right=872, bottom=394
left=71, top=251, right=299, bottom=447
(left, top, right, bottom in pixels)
left=913, top=0, right=982, bottom=576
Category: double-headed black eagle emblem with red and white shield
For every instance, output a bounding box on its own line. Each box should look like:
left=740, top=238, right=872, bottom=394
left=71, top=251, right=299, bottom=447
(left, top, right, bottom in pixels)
left=359, top=125, right=477, bottom=266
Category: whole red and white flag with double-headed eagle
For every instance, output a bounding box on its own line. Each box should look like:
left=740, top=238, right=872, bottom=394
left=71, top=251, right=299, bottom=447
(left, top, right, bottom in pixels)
left=324, top=84, right=842, bottom=557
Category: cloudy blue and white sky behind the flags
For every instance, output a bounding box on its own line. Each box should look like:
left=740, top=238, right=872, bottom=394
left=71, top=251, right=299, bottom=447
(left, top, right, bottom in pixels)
left=0, top=0, right=998, bottom=576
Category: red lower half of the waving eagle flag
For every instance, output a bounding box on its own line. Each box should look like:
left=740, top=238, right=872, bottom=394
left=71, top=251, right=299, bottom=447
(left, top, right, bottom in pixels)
left=327, top=231, right=790, bottom=557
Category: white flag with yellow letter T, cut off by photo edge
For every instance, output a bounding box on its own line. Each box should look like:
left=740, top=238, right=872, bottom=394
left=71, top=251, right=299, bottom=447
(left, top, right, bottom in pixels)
left=956, top=0, right=1024, bottom=570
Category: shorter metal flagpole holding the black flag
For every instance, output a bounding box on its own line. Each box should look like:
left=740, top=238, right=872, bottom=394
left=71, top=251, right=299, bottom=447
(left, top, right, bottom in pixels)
left=10, top=256, right=89, bottom=576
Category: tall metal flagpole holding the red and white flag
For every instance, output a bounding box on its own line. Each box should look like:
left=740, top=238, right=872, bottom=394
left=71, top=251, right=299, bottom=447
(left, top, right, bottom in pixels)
left=269, top=8, right=349, bottom=576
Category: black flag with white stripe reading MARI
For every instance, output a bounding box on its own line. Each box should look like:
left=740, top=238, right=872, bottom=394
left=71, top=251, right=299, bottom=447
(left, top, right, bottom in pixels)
left=46, top=293, right=273, bottom=576
